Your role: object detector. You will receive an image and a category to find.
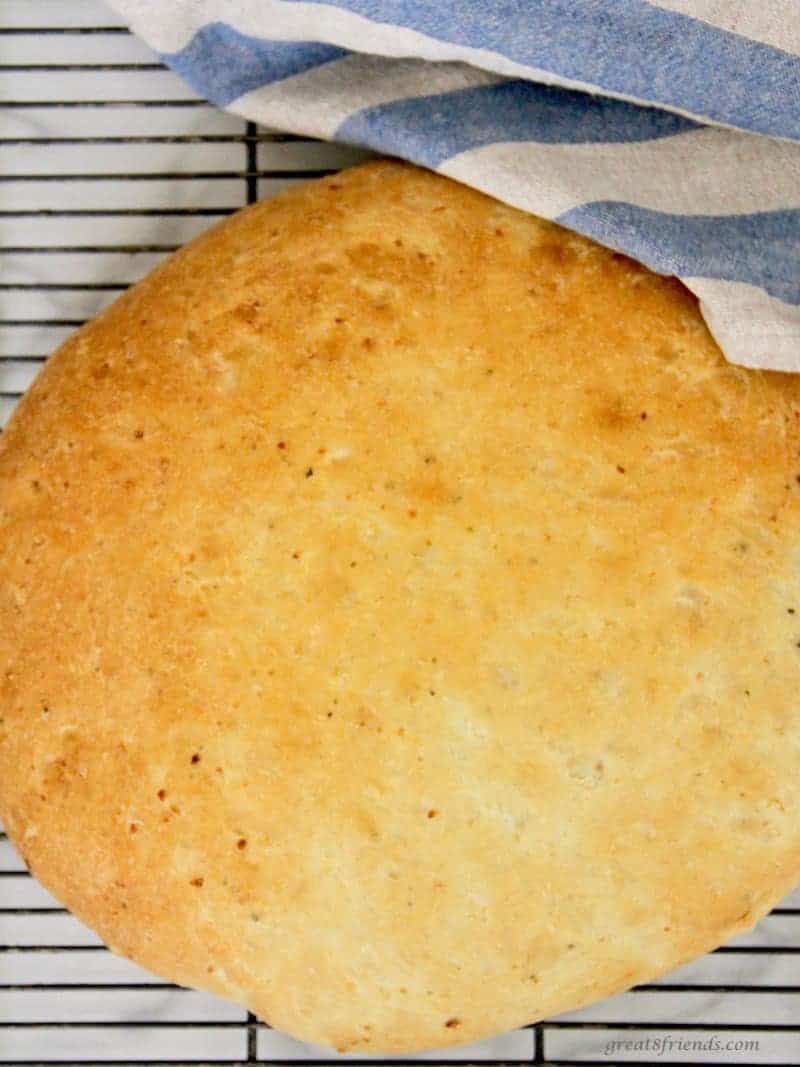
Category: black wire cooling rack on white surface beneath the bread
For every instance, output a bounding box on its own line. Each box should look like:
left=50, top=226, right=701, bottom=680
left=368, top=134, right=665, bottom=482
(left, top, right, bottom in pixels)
left=0, top=0, right=800, bottom=1065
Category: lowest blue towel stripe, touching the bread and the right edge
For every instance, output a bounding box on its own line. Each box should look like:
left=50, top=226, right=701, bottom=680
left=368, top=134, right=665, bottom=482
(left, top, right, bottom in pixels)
left=557, top=201, right=800, bottom=304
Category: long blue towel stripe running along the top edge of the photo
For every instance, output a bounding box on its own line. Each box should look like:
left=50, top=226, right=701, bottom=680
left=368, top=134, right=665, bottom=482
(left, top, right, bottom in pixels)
left=286, top=0, right=800, bottom=139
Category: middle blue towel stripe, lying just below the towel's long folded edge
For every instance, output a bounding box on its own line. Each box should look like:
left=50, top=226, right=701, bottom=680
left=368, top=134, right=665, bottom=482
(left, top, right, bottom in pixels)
left=335, top=79, right=698, bottom=166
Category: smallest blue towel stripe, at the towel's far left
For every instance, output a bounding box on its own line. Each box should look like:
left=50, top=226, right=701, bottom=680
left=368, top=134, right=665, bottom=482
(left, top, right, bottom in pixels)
left=161, top=22, right=349, bottom=107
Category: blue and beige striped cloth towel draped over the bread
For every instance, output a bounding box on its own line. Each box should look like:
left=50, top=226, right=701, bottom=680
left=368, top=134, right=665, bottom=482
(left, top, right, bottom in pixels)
left=114, top=0, right=800, bottom=371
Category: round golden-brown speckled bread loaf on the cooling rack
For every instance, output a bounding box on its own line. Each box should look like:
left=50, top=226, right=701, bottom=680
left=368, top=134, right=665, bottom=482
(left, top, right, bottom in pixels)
left=0, top=162, right=800, bottom=1052
